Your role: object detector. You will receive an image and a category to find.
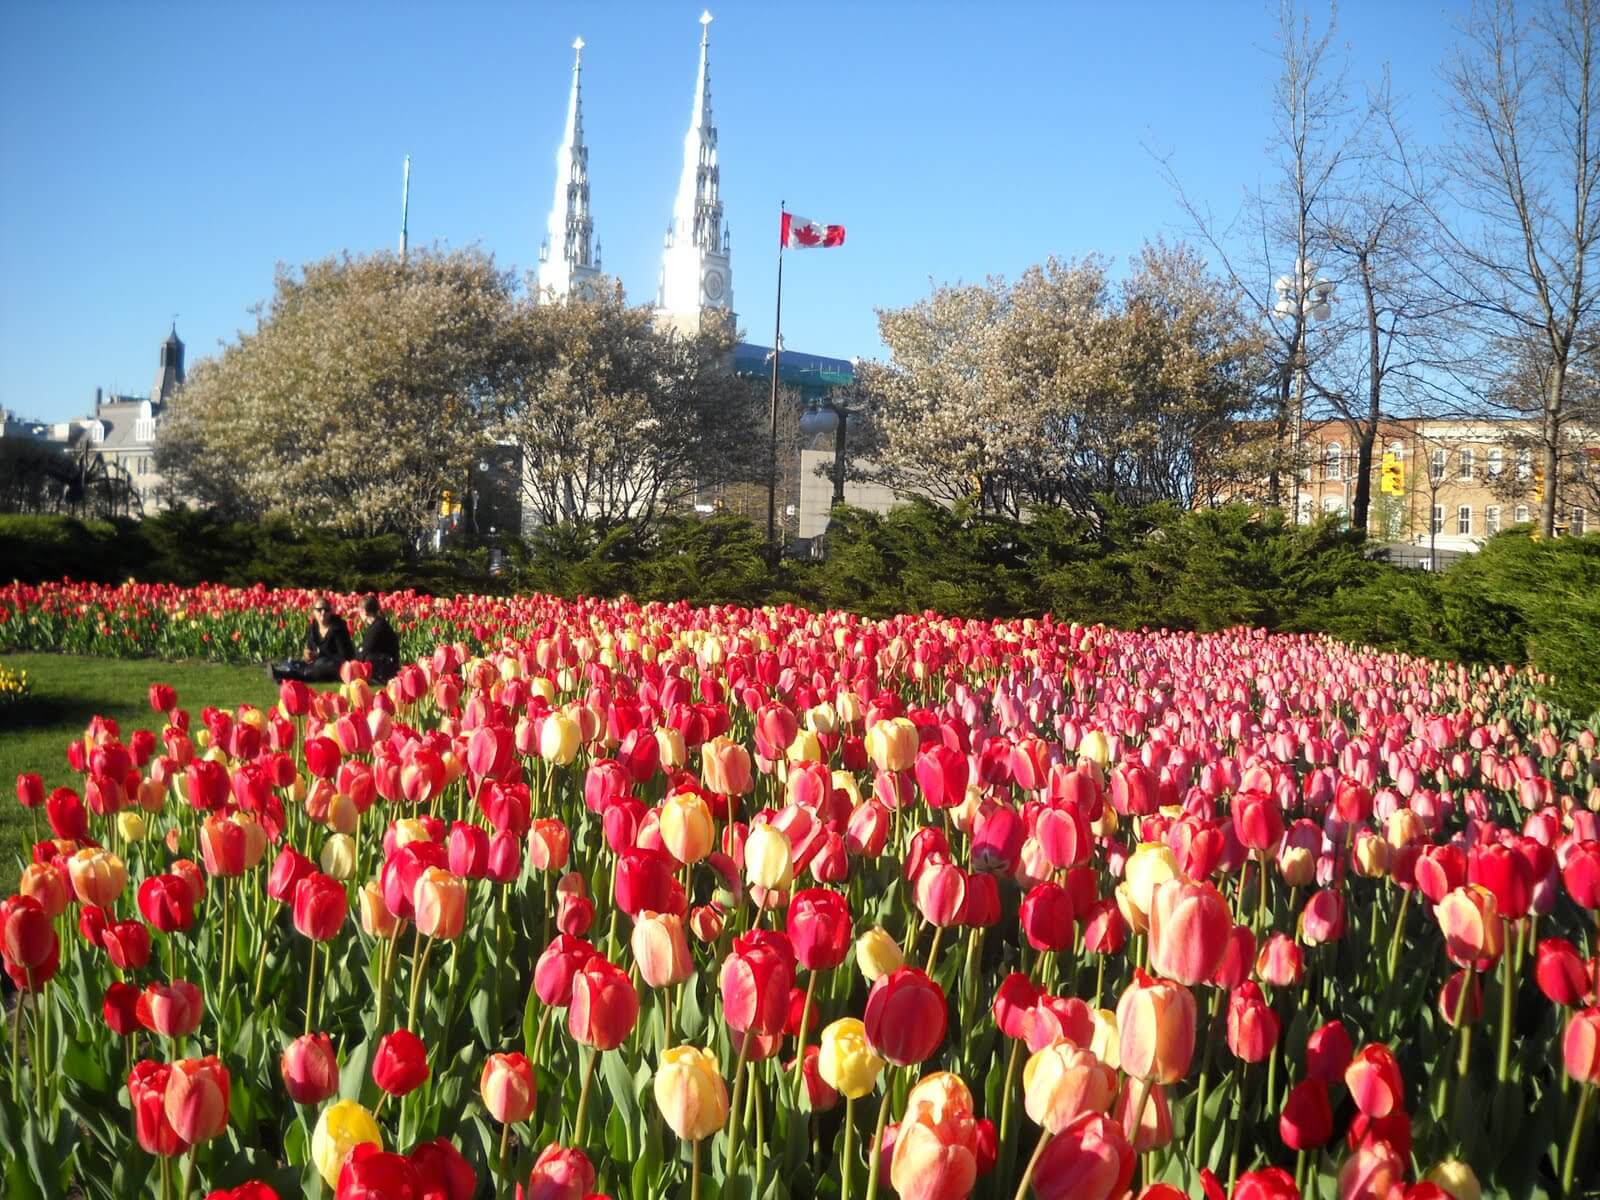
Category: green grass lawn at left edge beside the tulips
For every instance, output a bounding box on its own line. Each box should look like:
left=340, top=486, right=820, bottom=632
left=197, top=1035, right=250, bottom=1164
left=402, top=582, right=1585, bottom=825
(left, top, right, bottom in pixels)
left=0, top=654, right=278, bottom=896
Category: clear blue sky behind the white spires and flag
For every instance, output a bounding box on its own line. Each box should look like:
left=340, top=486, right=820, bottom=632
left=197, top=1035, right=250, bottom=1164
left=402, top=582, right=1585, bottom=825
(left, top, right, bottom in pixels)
left=0, top=0, right=1459, bottom=419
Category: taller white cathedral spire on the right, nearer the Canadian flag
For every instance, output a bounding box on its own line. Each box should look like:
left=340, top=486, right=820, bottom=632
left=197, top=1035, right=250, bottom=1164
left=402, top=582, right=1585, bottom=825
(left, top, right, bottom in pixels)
left=656, top=13, right=733, bottom=330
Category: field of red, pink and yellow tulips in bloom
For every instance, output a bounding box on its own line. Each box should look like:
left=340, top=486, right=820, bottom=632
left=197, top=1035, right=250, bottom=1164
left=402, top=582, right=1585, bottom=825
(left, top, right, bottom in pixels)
left=0, top=584, right=1600, bottom=1200
